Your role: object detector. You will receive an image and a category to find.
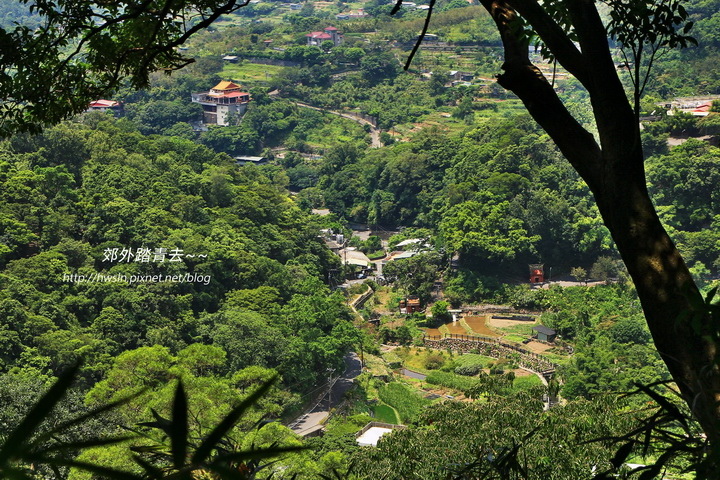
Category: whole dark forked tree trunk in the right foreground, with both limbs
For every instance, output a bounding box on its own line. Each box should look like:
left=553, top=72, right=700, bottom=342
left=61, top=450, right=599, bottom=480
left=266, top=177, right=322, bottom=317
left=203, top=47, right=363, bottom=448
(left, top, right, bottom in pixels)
left=481, top=0, right=720, bottom=443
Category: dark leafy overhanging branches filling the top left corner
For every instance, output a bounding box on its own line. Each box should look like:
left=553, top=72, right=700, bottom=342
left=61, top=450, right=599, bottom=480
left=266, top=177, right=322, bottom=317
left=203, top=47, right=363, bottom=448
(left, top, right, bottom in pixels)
left=0, top=0, right=242, bottom=136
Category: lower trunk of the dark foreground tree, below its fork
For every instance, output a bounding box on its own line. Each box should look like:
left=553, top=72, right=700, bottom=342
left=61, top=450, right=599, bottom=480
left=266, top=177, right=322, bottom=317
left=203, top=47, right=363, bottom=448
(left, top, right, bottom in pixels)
left=594, top=156, right=720, bottom=442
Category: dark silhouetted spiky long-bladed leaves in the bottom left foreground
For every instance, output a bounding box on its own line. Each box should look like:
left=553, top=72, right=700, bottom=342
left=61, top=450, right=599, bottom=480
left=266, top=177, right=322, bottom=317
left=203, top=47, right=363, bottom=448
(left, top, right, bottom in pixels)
left=0, top=365, right=305, bottom=480
